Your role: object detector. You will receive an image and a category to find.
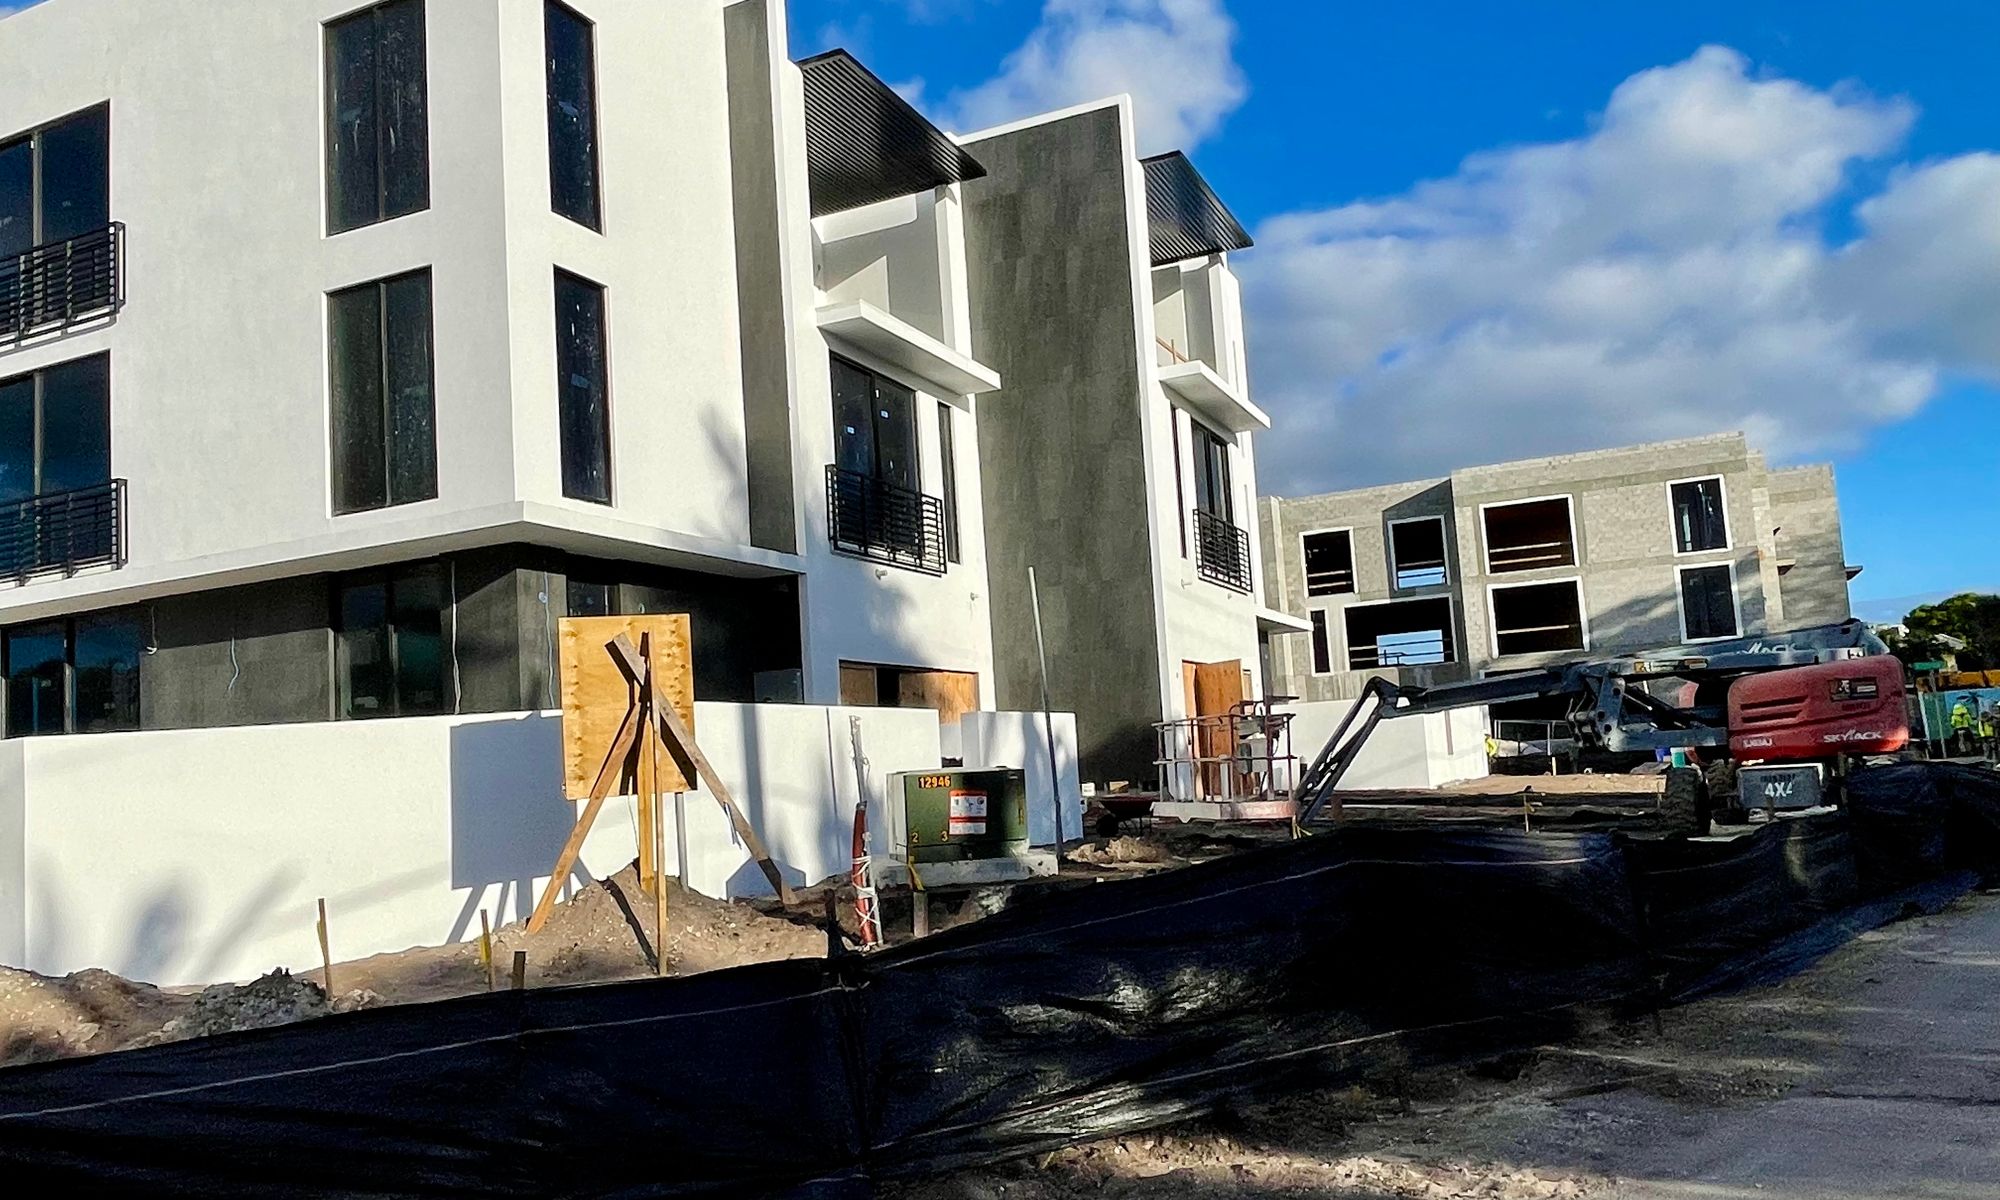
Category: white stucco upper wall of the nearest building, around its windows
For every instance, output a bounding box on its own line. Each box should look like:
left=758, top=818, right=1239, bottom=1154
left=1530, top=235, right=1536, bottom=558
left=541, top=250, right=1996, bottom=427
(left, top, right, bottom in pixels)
left=0, top=0, right=798, bottom=636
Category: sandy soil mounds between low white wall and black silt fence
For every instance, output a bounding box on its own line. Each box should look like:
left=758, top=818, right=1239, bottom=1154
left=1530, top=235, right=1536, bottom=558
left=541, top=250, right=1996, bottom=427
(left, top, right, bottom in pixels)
left=0, top=866, right=826, bottom=1066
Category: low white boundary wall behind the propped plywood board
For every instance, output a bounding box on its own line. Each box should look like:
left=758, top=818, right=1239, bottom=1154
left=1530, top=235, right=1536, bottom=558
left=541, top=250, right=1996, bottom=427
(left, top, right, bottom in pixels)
left=0, top=704, right=988, bottom=984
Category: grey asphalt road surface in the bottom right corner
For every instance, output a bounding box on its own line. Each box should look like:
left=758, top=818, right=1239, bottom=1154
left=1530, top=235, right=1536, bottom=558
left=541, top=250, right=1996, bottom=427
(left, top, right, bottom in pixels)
left=1598, top=896, right=2000, bottom=1200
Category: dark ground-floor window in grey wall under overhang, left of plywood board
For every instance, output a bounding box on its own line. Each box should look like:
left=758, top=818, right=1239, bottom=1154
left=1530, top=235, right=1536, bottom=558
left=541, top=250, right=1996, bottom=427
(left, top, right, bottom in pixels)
left=336, top=562, right=450, bottom=720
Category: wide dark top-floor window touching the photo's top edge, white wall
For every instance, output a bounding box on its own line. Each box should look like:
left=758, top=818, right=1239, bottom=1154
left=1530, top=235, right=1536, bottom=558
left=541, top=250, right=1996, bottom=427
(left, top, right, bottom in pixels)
left=326, top=0, right=430, bottom=234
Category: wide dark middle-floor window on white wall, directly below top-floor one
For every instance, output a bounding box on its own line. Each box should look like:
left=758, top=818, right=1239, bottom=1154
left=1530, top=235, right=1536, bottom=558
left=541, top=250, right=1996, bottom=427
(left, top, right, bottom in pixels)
left=326, top=270, right=438, bottom=512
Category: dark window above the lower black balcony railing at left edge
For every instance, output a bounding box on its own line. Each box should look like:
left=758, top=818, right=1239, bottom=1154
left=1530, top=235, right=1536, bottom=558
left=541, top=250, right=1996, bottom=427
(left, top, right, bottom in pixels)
left=0, top=354, right=112, bottom=500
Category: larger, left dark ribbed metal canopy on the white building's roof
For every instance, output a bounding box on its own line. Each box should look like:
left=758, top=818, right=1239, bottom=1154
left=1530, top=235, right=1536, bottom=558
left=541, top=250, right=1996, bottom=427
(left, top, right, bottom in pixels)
left=798, top=50, right=986, bottom=216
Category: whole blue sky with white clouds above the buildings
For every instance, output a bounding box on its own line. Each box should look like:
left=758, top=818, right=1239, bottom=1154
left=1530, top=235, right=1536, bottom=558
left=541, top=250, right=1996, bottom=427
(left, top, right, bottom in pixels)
left=792, top=0, right=2000, bottom=616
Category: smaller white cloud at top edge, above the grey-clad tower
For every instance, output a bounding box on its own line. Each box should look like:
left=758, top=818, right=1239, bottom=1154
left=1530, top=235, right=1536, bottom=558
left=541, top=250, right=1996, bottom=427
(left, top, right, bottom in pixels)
left=942, top=0, right=1248, bottom=154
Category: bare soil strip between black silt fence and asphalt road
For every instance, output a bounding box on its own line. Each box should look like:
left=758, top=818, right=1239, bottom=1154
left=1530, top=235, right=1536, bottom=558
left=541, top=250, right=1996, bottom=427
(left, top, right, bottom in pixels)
left=884, top=898, right=2000, bottom=1200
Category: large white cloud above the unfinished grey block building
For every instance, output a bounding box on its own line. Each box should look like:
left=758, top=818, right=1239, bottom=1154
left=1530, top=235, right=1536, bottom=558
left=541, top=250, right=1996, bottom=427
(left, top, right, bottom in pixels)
left=1242, top=46, right=2000, bottom=494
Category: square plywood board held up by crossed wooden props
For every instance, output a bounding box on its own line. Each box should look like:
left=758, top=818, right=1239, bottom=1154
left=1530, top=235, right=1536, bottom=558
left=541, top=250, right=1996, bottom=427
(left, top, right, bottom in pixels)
left=558, top=612, right=694, bottom=800
